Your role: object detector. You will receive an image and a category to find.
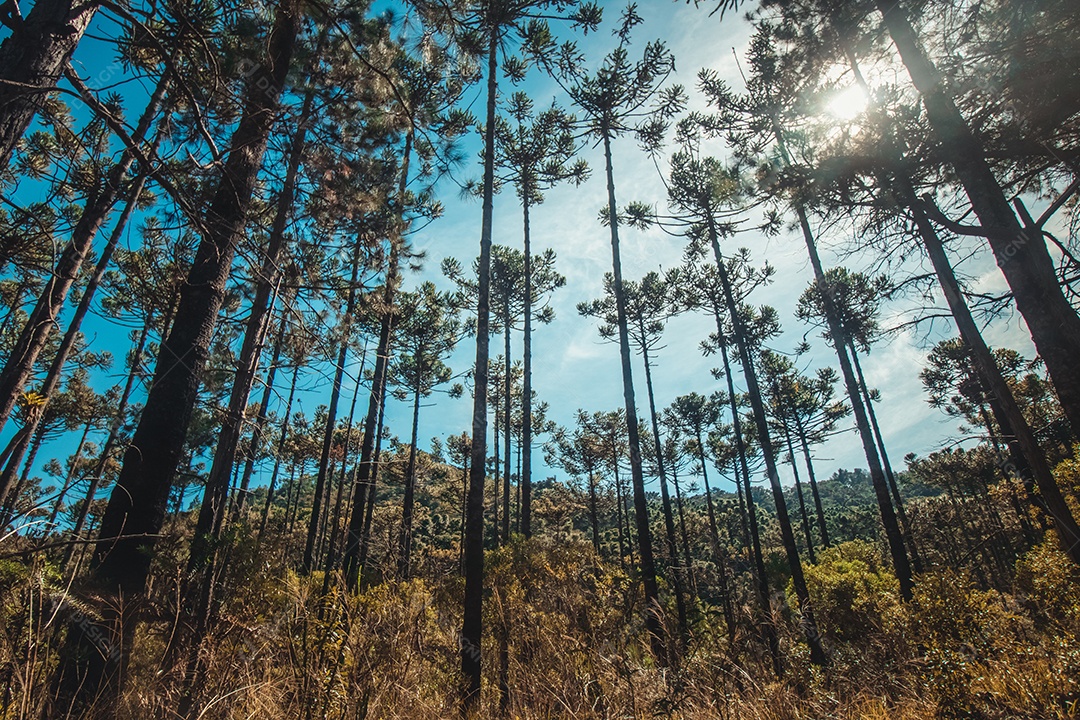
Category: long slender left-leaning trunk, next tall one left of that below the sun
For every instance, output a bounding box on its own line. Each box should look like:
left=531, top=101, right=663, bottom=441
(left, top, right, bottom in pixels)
left=708, top=215, right=825, bottom=665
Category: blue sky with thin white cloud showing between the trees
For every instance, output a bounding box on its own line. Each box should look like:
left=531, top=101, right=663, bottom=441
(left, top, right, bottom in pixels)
left=0, top=0, right=1034, bottom=511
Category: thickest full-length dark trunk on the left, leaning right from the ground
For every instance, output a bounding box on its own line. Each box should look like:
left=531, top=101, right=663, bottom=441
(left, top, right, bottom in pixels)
left=52, top=3, right=300, bottom=710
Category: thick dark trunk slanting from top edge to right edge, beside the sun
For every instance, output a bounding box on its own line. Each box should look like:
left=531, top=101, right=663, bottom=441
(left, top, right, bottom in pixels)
left=877, top=0, right=1080, bottom=436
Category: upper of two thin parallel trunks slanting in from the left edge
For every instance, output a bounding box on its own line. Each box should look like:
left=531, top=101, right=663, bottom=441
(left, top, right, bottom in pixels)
left=0, top=70, right=170, bottom=430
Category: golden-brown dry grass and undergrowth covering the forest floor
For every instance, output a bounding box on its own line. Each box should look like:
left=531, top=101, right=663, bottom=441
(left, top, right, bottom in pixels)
left=0, top=541, right=1080, bottom=720
